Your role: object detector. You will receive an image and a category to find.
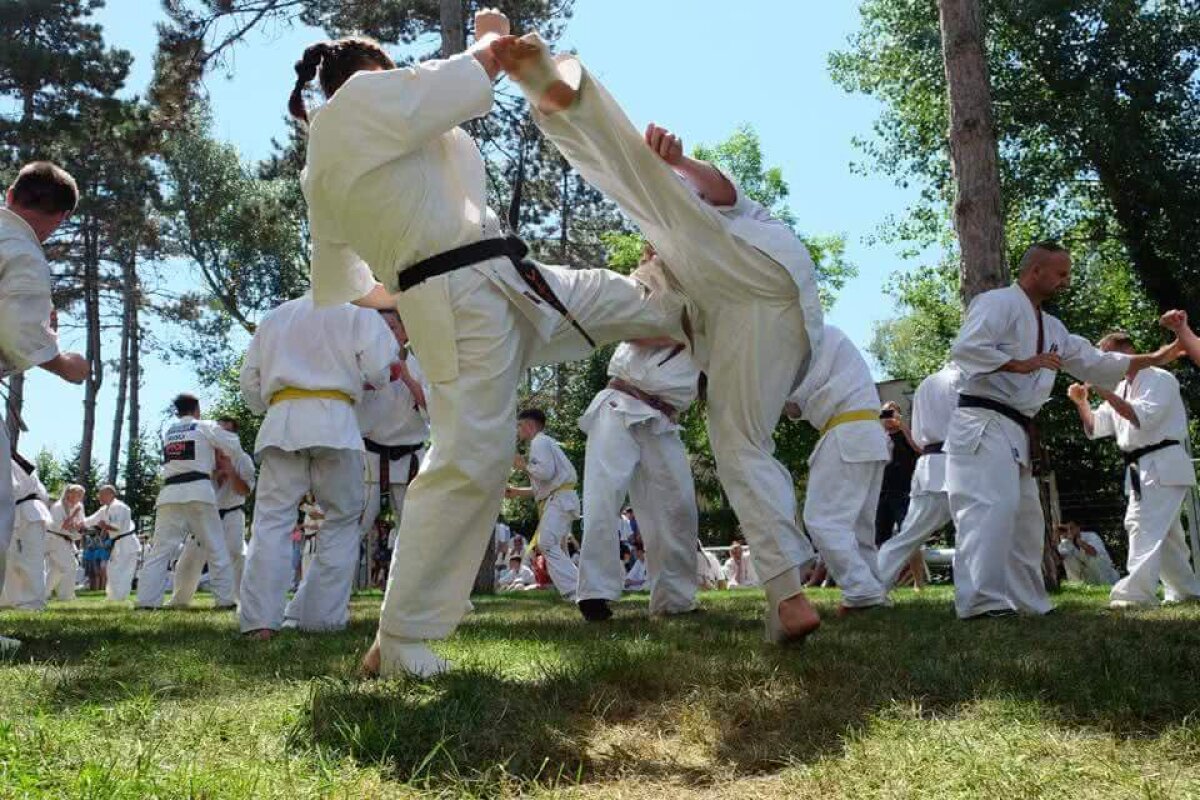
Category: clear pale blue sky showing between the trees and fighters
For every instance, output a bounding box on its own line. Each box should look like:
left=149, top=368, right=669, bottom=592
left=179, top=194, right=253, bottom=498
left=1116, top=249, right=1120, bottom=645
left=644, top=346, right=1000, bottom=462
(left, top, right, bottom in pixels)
left=22, top=0, right=914, bottom=459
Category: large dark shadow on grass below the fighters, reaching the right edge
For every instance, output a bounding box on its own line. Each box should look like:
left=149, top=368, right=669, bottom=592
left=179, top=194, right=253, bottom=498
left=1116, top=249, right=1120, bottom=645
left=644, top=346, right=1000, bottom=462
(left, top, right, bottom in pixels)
left=290, top=594, right=1200, bottom=793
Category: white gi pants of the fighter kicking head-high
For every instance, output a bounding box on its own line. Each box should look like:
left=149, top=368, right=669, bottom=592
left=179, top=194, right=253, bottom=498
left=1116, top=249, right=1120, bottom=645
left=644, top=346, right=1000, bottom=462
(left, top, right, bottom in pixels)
left=535, top=67, right=816, bottom=582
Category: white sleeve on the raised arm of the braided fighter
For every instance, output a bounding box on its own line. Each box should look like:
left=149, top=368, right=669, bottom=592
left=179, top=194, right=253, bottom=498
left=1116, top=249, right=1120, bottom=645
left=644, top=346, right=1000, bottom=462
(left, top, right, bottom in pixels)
left=336, top=53, right=494, bottom=155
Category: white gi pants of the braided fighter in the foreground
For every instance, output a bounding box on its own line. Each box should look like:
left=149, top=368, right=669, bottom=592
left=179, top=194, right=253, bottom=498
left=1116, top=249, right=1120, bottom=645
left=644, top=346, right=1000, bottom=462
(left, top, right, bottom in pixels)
left=376, top=266, right=679, bottom=664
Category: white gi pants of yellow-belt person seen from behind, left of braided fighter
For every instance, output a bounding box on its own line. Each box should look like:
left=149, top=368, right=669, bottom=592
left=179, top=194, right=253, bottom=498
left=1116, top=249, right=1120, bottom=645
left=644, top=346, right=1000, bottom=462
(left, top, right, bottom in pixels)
left=239, top=447, right=366, bottom=632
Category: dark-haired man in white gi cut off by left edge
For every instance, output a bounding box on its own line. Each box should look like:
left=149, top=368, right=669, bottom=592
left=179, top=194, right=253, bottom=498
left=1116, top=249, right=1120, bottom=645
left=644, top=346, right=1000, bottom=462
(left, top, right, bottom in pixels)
left=0, top=161, right=90, bottom=652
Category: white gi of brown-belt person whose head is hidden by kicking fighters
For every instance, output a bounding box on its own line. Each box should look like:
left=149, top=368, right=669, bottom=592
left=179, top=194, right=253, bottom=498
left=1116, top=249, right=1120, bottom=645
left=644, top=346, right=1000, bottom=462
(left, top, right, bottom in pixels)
left=578, top=343, right=700, bottom=614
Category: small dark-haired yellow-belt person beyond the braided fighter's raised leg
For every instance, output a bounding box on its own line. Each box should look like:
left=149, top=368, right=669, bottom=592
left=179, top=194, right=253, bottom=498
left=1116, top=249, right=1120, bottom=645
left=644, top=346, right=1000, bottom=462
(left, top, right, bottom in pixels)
left=504, top=408, right=580, bottom=602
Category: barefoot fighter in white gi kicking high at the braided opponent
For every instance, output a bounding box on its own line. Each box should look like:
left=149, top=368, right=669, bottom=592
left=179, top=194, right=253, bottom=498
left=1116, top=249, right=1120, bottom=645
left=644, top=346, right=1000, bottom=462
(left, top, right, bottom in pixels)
left=493, top=35, right=823, bottom=643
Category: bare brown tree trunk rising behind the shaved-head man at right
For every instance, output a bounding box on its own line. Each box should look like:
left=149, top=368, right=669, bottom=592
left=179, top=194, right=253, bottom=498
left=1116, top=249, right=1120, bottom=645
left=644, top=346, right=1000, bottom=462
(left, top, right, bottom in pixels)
left=937, top=0, right=1009, bottom=305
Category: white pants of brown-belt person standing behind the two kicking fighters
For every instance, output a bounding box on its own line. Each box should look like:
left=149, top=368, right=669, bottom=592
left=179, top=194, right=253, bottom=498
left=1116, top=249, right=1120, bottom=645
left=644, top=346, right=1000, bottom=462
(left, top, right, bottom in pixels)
left=578, top=403, right=700, bottom=614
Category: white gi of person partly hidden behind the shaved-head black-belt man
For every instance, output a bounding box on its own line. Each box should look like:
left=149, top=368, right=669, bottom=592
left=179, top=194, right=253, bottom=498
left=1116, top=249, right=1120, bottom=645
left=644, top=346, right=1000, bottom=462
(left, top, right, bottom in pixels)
left=878, top=363, right=959, bottom=589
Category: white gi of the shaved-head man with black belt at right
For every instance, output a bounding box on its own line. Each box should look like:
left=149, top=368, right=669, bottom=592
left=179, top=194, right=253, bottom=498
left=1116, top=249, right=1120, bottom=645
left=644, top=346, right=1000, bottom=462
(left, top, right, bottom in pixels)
left=946, top=284, right=1129, bottom=619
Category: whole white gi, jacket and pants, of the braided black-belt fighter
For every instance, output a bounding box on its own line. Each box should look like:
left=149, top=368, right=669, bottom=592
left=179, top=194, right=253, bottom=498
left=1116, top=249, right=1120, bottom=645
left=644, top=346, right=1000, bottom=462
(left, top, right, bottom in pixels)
left=300, top=54, right=683, bottom=673
